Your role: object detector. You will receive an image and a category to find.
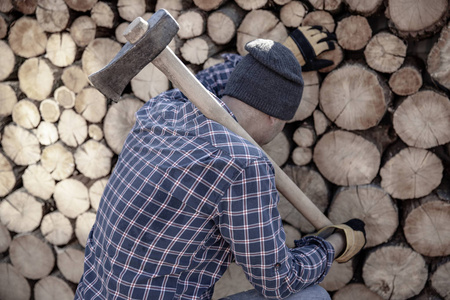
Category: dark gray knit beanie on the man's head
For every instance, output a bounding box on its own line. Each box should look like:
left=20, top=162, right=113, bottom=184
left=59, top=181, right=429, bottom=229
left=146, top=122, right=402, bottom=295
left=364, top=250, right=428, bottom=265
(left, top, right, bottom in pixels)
left=224, top=39, right=303, bottom=121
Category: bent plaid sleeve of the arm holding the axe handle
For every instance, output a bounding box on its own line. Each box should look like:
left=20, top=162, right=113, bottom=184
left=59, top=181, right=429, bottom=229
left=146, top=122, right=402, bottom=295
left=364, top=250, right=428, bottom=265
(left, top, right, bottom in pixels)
left=219, top=161, right=334, bottom=299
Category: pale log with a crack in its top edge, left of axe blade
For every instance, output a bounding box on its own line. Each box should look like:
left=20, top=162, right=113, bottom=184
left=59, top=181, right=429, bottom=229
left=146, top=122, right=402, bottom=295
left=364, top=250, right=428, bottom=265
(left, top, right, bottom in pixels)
left=45, top=32, right=77, bottom=67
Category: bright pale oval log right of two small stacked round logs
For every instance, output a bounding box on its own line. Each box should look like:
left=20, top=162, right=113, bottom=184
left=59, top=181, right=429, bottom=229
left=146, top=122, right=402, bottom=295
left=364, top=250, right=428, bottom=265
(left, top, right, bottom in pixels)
left=58, top=109, right=87, bottom=147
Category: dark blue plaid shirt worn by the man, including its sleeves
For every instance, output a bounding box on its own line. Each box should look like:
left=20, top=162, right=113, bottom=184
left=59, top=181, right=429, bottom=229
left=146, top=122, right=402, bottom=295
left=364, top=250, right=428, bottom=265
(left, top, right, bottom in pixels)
left=75, top=54, right=334, bottom=300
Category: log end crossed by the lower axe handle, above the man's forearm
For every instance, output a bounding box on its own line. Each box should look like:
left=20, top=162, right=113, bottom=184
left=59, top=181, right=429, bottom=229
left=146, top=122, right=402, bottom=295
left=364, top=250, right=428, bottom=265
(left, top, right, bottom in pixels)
left=278, top=164, right=330, bottom=233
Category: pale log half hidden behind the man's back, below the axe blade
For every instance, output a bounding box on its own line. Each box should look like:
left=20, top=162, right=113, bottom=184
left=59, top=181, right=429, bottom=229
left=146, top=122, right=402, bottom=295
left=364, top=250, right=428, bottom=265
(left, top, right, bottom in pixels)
left=103, top=98, right=143, bottom=154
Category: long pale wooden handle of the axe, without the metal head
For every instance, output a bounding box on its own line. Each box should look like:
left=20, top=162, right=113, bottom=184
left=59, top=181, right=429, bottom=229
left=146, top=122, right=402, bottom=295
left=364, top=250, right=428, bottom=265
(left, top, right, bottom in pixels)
left=152, top=47, right=332, bottom=229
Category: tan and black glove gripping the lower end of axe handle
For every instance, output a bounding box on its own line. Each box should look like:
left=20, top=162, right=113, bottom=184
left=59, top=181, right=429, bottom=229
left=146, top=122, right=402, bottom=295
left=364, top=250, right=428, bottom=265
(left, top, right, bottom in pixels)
left=316, top=219, right=366, bottom=263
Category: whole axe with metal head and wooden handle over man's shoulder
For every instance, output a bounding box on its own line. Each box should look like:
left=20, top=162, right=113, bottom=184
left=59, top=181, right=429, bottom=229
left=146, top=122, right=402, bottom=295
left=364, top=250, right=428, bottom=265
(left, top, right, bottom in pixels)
left=89, top=9, right=332, bottom=229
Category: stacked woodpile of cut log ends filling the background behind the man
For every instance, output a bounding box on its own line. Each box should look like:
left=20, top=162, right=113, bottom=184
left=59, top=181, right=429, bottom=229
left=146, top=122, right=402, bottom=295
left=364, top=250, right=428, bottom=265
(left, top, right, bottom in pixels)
left=0, top=0, right=450, bottom=300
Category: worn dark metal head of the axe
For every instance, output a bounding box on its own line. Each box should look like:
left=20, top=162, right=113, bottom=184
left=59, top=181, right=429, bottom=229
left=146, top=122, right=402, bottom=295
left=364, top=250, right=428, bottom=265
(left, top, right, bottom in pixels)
left=89, top=9, right=179, bottom=101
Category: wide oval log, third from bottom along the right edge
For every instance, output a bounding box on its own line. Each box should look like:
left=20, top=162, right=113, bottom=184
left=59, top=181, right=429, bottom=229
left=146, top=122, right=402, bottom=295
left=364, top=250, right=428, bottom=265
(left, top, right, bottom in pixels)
left=380, top=147, right=443, bottom=200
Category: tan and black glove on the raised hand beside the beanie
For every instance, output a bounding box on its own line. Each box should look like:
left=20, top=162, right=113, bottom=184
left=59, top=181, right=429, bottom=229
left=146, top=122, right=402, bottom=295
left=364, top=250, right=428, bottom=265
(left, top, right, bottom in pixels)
left=283, top=26, right=336, bottom=72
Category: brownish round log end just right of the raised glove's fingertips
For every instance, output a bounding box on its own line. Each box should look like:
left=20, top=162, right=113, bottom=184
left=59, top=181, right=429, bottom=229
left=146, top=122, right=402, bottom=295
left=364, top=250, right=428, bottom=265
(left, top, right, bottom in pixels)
left=336, top=15, right=372, bottom=51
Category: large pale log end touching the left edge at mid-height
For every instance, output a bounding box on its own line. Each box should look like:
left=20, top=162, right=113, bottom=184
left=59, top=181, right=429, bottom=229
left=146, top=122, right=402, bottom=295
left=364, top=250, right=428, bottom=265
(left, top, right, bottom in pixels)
left=2, top=124, right=41, bottom=166
